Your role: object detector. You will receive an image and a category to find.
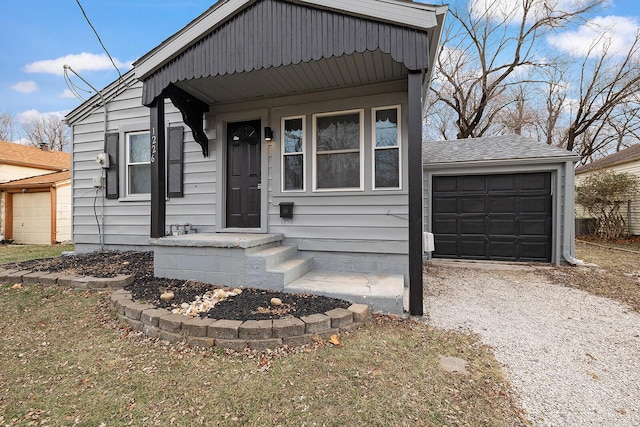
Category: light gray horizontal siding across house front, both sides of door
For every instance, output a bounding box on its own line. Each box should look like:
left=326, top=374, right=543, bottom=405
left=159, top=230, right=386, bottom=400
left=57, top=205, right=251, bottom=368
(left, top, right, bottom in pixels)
left=73, top=76, right=408, bottom=260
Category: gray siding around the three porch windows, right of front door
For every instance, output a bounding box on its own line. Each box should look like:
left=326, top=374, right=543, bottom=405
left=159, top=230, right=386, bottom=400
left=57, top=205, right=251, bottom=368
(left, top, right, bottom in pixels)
left=268, top=84, right=409, bottom=254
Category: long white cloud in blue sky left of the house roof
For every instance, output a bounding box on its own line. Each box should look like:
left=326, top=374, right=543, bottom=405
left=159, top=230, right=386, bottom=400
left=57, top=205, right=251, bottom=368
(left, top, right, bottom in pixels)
left=25, top=52, right=132, bottom=76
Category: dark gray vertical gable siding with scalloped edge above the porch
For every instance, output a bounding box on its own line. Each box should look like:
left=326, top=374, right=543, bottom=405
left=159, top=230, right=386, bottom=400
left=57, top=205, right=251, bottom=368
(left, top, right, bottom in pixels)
left=142, top=0, right=430, bottom=105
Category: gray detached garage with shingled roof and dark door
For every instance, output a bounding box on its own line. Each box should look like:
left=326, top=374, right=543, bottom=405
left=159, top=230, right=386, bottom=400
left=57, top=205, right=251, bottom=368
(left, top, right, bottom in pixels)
left=423, top=135, right=578, bottom=264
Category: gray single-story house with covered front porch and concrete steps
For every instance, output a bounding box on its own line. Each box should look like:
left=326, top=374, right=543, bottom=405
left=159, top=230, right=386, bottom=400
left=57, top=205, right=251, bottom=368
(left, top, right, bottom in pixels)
left=67, top=0, right=447, bottom=315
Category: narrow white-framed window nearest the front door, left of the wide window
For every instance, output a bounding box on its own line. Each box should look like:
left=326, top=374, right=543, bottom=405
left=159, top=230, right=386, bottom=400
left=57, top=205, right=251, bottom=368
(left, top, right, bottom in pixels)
left=282, top=116, right=305, bottom=191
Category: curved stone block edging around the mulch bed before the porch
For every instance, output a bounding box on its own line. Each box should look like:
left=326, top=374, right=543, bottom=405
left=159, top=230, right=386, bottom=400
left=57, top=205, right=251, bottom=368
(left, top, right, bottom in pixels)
left=111, top=289, right=369, bottom=351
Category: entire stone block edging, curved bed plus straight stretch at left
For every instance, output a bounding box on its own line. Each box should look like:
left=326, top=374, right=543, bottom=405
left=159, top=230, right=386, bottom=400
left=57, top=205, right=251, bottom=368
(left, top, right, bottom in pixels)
left=0, top=267, right=370, bottom=351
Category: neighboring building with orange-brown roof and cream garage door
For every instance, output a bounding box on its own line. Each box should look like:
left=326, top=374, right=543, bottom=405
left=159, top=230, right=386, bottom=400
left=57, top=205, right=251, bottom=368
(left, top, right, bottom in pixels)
left=0, top=141, right=71, bottom=244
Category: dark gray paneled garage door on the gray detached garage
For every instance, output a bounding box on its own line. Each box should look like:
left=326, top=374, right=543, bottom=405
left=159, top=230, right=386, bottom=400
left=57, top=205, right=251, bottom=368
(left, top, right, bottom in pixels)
left=432, top=172, right=552, bottom=262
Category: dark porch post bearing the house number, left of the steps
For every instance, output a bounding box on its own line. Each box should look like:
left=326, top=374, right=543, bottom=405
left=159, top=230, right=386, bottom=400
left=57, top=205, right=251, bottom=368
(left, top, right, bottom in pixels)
left=149, top=95, right=166, bottom=238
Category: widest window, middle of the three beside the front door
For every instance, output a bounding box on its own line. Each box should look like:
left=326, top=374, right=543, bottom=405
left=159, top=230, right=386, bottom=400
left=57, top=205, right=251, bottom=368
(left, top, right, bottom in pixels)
left=313, top=110, right=363, bottom=190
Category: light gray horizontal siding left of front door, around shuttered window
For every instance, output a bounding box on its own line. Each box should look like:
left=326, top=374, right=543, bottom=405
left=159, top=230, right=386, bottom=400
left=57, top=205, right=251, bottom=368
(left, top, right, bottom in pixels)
left=73, top=83, right=215, bottom=252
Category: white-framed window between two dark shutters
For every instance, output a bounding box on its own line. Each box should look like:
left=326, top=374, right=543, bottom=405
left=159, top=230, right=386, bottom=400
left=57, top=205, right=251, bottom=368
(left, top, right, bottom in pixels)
left=126, top=131, right=151, bottom=195
